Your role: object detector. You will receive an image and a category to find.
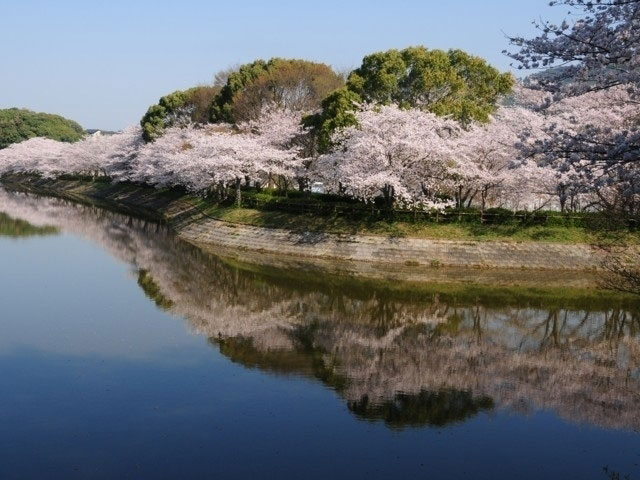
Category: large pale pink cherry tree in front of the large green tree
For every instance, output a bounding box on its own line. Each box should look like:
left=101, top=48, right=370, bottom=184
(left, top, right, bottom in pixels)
left=313, top=105, right=461, bottom=208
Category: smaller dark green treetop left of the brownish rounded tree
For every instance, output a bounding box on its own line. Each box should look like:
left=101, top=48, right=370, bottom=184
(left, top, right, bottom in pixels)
left=140, top=86, right=220, bottom=142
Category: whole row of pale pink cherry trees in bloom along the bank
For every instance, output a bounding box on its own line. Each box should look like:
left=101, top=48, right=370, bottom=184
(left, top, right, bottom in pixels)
left=0, top=87, right=637, bottom=213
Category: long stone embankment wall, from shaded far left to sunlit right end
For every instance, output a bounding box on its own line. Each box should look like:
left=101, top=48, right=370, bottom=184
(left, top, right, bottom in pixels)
left=3, top=176, right=603, bottom=273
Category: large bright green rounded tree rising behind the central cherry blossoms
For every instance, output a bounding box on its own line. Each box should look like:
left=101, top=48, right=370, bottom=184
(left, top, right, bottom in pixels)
left=305, top=47, right=514, bottom=150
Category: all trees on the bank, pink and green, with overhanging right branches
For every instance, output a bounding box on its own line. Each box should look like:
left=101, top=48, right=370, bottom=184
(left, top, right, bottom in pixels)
left=0, top=0, right=640, bottom=216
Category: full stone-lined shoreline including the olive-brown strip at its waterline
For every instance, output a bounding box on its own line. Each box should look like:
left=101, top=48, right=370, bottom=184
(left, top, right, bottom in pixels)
left=1, top=174, right=616, bottom=287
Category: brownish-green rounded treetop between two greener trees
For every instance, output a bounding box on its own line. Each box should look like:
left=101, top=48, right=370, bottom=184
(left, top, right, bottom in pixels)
left=211, top=58, right=344, bottom=123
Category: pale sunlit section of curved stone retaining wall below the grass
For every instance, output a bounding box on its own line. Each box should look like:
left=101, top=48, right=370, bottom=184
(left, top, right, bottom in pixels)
left=178, top=218, right=603, bottom=270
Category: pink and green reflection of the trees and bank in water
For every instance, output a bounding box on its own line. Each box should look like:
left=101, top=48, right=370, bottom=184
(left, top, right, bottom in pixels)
left=0, top=191, right=640, bottom=430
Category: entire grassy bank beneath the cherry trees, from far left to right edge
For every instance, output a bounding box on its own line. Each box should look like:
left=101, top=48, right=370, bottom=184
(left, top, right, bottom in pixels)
left=2, top=173, right=640, bottom=245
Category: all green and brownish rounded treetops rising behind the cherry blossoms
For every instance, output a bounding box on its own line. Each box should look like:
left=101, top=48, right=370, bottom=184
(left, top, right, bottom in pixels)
left=140, top=47, right=514, bottom=151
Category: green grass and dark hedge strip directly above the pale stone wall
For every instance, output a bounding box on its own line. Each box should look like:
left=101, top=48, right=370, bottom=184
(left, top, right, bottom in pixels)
left=183, top=188, right=640, bottom=244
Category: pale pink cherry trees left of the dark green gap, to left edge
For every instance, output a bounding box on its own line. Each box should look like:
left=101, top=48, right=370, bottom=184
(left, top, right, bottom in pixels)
left=0, top=110, right=302, bottom=204
